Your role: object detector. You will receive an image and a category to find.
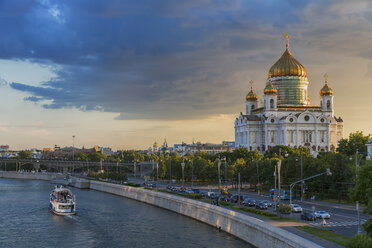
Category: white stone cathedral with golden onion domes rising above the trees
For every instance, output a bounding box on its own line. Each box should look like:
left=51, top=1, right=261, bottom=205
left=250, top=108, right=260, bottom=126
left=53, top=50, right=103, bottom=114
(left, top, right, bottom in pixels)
left=235, top=35, right=343, bottom=156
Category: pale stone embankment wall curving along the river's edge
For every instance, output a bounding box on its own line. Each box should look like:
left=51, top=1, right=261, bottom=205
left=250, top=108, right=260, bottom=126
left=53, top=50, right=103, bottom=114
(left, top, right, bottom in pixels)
left=90, top=181, right=321, bottom=248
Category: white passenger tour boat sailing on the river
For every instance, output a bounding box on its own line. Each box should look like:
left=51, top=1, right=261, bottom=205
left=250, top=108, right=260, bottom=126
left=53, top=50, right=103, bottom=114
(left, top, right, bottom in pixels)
left=49, top=186, right=76, bottom=215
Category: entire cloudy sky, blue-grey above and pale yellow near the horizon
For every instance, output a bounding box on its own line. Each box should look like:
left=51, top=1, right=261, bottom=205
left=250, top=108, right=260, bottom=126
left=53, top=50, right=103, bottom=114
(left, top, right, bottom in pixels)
left=0, top=0, right=372, bottom=149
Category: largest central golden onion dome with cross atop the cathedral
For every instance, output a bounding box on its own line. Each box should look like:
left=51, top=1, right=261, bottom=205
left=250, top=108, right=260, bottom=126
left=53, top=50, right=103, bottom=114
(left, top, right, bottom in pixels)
left=270, top=34, right=307, bottom=77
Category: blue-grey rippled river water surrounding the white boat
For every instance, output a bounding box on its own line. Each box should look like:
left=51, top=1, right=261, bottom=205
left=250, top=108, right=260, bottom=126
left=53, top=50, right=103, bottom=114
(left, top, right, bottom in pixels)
left=0, top=178, right=249, bottom=248
